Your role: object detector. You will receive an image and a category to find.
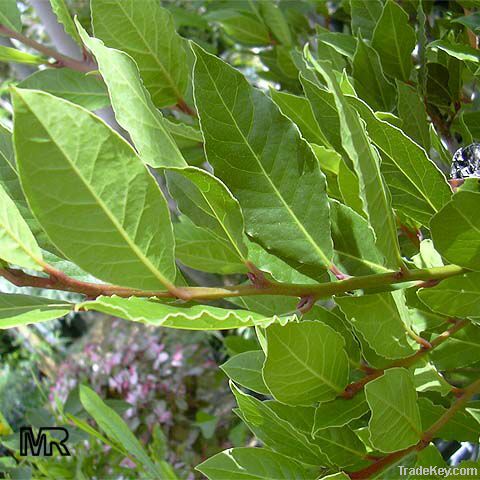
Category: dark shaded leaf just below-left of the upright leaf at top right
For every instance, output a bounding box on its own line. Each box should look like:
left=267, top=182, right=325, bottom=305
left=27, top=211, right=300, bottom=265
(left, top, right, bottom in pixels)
left=353, top=38, right=396, bottom=111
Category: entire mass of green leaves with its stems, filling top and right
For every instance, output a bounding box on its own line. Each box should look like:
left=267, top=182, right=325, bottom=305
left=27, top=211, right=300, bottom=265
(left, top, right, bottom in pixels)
left=0, top=0, right=480, bottom=479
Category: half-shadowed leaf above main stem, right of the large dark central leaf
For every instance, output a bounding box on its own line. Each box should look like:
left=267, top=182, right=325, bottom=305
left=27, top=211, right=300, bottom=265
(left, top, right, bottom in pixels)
left=330, top=200, right=388, bottom=275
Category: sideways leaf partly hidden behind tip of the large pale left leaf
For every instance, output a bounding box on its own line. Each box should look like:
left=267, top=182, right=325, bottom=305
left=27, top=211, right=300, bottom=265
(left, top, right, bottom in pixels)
left=18, top=68, right=110, bottom=110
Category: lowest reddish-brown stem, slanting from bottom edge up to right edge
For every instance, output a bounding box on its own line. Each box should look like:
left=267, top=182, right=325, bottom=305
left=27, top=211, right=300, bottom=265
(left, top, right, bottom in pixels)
left=348, top=376, right=480, bottom=480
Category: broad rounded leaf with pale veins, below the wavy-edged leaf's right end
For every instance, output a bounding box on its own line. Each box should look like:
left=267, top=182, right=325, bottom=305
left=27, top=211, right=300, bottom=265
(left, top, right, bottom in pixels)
left=263, top=321, right=349, bottom=405
